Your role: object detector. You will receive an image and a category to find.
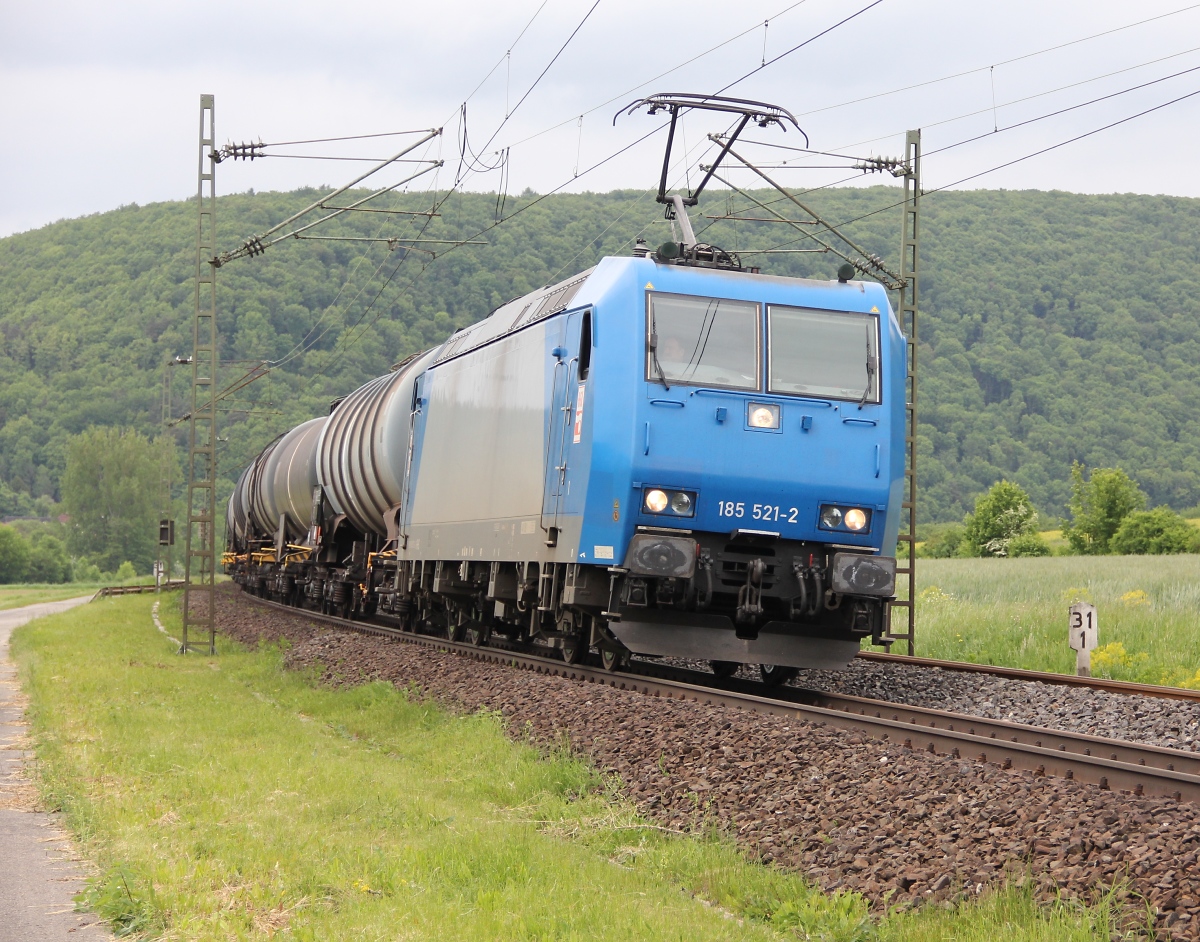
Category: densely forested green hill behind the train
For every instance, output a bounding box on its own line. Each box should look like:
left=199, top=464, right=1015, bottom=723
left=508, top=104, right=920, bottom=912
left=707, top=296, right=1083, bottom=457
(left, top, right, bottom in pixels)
left=0, top=187, right=1200, bottom=520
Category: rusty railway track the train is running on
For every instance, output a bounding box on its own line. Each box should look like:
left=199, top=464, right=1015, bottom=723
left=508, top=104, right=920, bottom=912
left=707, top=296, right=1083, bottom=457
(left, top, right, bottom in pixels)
left=246, top=595, right=1200, bottom=803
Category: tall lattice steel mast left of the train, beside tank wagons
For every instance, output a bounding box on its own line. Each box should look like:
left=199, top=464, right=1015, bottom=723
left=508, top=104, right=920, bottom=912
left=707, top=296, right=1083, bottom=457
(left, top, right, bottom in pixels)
left=180, top=95, right=217, bottom=654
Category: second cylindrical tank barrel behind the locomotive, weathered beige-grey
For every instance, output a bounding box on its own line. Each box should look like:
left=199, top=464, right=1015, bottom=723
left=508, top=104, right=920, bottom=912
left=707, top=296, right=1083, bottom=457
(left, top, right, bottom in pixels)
left=252, top=415, right=326, bottom=540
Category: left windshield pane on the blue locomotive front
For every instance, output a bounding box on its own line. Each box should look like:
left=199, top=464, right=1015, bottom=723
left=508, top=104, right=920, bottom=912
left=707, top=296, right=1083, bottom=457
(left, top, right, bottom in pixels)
left=646, top=293, right=760, bottom=390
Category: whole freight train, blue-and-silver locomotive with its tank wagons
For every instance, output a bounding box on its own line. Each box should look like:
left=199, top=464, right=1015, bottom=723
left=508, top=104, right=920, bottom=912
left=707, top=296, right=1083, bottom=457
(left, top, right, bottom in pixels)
left=224, top=244, right=906, bottom=682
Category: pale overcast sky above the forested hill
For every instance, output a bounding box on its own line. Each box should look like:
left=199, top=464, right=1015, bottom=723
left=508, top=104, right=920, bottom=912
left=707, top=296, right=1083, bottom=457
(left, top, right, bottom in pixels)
left=0, top=0, right=1200, bottom=235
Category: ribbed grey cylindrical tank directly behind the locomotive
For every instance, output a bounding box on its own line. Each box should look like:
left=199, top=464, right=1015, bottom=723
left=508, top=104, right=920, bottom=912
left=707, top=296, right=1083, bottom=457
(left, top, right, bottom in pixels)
left=317, top=348, right=438, bottom=535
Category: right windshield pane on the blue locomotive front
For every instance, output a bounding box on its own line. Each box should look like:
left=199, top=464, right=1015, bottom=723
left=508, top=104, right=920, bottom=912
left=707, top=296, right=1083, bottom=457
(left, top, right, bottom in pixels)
left=767, top=305, right=880, bottom=402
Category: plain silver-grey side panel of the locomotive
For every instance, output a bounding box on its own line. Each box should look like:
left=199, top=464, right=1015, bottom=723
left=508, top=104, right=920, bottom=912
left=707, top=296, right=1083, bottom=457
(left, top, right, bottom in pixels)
left=402, top=316, right=580, bottom=562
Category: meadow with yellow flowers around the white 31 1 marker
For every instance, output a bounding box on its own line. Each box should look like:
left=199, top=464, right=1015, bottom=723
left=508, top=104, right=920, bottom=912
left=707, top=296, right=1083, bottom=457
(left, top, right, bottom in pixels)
left=917, top=556, right=1200, bottom=688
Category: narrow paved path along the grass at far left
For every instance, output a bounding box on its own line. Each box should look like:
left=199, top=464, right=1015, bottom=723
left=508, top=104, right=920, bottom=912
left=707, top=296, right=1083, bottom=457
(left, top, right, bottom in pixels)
left=0, top=595, right=110, bottom=942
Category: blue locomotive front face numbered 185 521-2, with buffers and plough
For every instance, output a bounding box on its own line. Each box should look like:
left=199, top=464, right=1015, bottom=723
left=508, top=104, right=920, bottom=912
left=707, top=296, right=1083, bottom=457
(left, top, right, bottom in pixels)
left=595, top=259, right=905, bottom=670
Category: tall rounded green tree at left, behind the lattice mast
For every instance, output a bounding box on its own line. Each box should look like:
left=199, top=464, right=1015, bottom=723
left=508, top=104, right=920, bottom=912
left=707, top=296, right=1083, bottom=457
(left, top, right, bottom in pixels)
left=62, top=428, right=161, bottom=572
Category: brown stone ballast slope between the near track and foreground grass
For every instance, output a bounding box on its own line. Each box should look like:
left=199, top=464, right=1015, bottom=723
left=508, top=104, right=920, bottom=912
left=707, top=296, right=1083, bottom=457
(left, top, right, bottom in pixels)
left=217, top=588, right=1200, bottom=938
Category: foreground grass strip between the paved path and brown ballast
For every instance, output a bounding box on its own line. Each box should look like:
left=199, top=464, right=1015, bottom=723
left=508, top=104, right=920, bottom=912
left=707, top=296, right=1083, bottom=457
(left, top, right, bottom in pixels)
left=13, top=596, right=1123, bottom=942
